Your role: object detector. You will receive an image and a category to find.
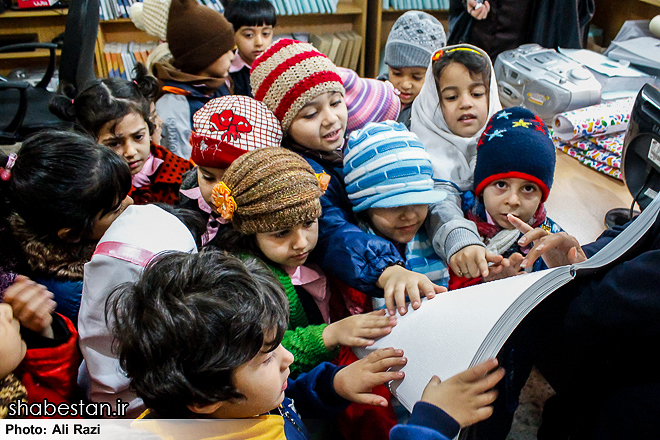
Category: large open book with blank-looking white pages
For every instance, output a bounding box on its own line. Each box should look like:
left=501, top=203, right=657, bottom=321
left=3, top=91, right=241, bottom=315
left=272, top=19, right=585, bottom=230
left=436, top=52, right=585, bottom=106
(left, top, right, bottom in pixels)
left=355, top=197, right=660, bottom=411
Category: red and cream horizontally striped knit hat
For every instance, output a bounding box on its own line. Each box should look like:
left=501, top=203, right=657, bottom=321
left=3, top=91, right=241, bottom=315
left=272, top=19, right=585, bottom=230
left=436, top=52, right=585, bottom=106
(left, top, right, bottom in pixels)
left=250, top=39, right=344, bottom=134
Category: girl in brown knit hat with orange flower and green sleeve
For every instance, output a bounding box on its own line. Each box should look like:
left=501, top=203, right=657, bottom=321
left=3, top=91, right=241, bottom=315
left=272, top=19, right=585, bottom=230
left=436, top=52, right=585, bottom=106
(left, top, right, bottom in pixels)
left=213, top=148, right=396, bottom=375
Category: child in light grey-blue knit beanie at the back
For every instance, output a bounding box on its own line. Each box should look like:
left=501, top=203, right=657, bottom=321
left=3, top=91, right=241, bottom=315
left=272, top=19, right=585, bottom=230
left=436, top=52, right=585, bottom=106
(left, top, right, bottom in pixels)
left=383, top=11, right=447, bottom=129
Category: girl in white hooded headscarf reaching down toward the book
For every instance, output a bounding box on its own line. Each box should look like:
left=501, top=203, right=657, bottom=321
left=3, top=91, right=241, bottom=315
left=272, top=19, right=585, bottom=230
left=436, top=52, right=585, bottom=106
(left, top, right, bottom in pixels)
left=410, top=44, right=502, bottom=286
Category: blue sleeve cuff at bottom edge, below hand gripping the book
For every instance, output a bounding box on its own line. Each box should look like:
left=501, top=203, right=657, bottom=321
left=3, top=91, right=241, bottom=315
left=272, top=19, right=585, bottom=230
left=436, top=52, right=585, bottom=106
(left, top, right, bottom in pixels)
left=390, top=402, right=460, bottom=440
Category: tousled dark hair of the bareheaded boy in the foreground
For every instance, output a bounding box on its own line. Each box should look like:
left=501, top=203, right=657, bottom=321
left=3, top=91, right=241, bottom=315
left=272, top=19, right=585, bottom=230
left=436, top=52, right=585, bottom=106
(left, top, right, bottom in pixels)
left=106, top=249, right=289, bottom=418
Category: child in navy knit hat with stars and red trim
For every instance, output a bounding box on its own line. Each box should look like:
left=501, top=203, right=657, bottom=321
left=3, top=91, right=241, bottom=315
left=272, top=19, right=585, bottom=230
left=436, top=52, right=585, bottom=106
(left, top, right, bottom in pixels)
left=449, top=107, right=561, bottom=289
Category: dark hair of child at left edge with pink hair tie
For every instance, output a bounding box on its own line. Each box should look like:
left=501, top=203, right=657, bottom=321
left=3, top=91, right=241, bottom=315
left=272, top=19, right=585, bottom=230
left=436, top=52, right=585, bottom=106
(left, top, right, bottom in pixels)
left=0, top=130, right=131, bottom=238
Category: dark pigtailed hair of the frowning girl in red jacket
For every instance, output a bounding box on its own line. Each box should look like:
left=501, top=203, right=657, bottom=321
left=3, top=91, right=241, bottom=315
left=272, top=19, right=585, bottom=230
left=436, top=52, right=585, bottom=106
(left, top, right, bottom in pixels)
left=49, top=63, right=158, bottom=137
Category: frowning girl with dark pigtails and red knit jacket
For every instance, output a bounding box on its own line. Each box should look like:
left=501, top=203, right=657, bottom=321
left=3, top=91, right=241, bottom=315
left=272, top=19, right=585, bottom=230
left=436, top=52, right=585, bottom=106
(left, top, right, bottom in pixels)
left=50, top=63, right=192, bottom=205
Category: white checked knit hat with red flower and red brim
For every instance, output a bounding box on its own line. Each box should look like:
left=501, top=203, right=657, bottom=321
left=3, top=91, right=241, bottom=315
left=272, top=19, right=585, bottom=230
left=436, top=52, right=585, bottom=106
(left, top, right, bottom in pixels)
left=190, top=95, right=282, bottom=169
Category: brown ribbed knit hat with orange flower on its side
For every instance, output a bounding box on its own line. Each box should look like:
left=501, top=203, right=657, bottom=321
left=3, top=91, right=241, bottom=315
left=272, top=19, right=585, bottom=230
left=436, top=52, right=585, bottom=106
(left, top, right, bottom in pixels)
left=213, top=147, right=327, bottom=235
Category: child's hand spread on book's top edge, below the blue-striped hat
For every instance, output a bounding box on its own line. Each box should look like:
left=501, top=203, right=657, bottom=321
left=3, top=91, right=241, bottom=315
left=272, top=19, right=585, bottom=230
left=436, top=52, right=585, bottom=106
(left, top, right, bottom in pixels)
left=376, top=265, right=447, bottom=315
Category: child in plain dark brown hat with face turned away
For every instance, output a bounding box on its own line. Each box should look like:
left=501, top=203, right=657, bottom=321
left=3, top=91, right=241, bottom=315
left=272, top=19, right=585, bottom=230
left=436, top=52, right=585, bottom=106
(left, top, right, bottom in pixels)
left=153, top=0, right=234, bottom=159
